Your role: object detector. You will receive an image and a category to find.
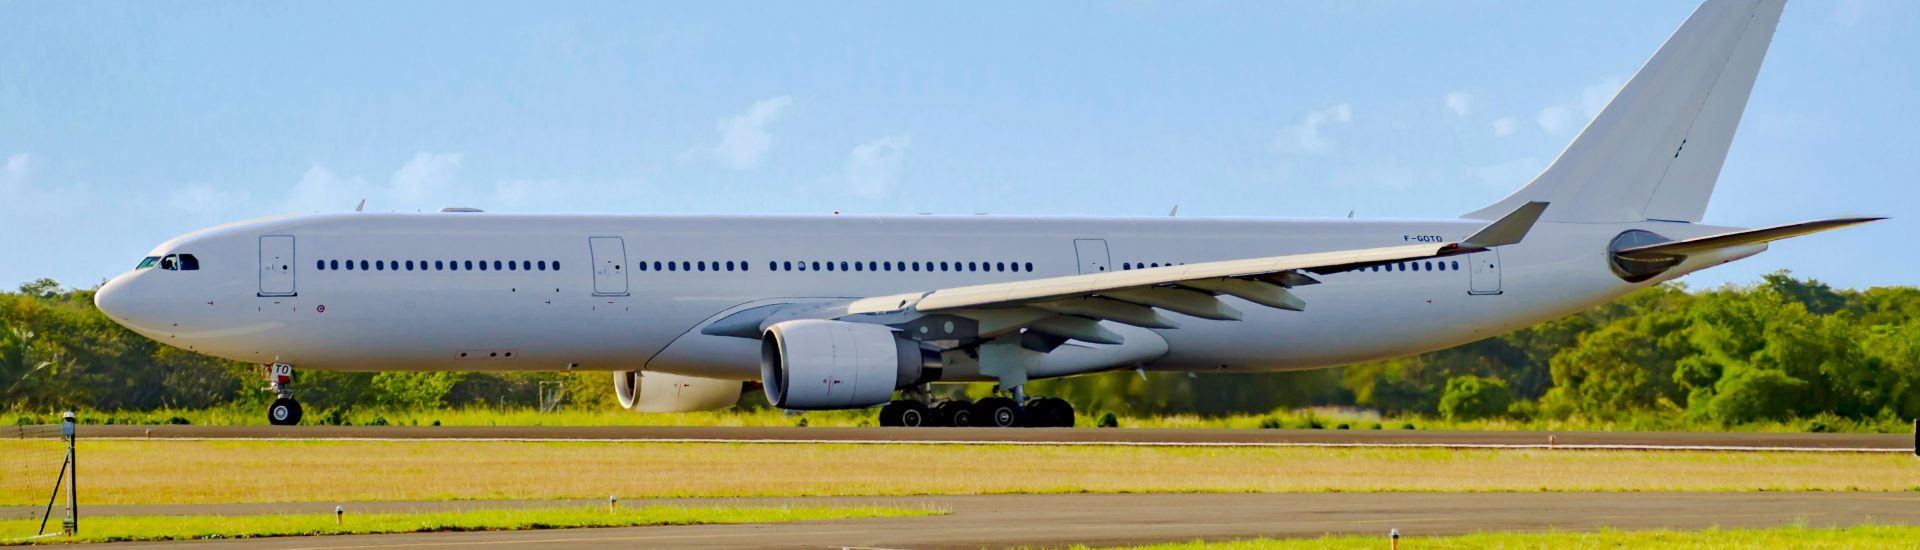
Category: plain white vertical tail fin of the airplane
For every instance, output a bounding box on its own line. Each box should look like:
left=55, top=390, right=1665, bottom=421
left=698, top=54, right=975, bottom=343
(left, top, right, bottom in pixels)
left=1465, top=0, right=1786, bottom=223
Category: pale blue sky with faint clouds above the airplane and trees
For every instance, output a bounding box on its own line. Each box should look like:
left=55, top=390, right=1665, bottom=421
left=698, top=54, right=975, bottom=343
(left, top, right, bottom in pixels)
left=0, top=0, right=1920, bottom=287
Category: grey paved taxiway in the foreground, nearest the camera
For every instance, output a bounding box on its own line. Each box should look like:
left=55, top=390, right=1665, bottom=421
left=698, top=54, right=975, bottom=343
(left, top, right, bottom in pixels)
left=92, top=492, right=1920, bottom=550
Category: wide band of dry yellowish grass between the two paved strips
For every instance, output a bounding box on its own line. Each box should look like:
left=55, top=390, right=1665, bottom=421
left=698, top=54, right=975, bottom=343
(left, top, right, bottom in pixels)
left=0, top=440, right=1920, bottom=506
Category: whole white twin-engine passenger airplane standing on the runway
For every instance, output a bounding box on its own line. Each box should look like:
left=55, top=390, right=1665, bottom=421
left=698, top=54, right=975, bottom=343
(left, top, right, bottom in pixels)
left=96, top=0, right=1880, bottom=427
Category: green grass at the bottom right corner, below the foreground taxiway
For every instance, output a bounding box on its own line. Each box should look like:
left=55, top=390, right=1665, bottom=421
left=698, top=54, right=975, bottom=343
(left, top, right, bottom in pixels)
left=1105, top=525, right=1920, bottom=550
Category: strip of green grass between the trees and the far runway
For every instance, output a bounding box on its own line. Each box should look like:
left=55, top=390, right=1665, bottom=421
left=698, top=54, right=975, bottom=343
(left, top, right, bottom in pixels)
left=0, top=406, right=1912, bottom=433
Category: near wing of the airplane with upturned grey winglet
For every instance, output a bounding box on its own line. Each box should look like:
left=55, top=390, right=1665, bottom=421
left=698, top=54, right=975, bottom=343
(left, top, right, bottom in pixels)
left=847, top=202, right=1548, bottom=330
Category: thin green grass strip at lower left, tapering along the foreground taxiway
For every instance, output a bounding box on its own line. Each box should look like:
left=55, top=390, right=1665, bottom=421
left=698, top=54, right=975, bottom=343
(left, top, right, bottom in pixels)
left=0, top=506, right=947, bottom=544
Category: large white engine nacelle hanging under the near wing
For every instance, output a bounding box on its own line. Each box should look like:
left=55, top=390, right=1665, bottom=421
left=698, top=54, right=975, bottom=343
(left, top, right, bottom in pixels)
left=760, top=319, right=941, bottom=410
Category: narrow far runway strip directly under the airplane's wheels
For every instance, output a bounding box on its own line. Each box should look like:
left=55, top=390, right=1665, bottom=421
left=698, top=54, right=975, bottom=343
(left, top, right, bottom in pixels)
left=79, top=425, right=1914, bottom=452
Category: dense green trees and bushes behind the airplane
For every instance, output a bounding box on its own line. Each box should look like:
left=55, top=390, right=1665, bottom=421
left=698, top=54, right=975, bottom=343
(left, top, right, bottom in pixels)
left=0, top=271, right=1920, bottom=431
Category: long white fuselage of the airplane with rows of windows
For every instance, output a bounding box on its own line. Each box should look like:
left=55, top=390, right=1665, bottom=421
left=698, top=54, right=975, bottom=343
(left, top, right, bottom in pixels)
left=98, top=213, right=1764, bottom=381
